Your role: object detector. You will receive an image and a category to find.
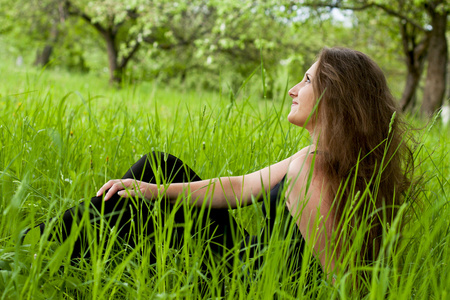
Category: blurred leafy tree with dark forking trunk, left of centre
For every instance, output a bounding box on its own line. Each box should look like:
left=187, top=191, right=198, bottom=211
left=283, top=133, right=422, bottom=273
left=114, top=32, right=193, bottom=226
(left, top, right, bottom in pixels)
left=65, top=0, right=284, bottom=83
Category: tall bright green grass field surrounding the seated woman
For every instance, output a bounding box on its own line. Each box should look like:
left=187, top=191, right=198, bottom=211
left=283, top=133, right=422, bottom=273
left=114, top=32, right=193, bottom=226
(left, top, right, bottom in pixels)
left=0, top=62, right=450, bottom=299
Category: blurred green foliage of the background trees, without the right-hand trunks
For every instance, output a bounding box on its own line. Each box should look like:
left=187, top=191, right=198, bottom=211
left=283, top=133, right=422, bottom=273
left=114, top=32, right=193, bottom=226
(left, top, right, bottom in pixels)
left=0, top=0, right=422, bottom=99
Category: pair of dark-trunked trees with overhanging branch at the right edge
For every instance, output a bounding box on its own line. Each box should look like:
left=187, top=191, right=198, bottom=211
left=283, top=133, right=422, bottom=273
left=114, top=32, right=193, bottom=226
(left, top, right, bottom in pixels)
left=304, top=0, right=450, bottom=115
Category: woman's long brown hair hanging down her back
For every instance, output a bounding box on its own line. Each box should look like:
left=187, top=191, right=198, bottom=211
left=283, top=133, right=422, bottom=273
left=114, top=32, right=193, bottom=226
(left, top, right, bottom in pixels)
left=313, top=48, right=413, bottom=263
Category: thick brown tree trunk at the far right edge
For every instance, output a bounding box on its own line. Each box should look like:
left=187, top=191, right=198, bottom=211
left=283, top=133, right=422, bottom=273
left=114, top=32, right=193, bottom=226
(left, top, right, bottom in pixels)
left=421, top=4, right=448, bottom=116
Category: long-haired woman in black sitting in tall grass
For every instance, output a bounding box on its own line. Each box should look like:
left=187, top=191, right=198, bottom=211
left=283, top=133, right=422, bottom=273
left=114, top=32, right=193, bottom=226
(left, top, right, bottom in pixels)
left=32, top=48, right=411, bottom=286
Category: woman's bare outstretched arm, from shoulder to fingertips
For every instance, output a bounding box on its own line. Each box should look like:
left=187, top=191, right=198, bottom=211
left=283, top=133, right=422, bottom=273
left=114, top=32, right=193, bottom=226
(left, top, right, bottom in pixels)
left=97, top=147, right=309, bottom=208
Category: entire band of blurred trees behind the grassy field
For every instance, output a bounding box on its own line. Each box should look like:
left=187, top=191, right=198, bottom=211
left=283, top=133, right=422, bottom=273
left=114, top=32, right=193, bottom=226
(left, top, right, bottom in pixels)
left=0, top=0, right=450, bottom=115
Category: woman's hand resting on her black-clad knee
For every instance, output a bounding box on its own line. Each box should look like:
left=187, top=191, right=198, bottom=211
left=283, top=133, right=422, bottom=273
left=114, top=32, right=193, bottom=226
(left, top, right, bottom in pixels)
left=97, top=179, right=154, bottom=201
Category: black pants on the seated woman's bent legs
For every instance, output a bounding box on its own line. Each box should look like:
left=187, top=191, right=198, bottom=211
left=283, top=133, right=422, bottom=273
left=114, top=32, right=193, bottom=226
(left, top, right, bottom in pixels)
left=38, top=152, right=242, bottom=261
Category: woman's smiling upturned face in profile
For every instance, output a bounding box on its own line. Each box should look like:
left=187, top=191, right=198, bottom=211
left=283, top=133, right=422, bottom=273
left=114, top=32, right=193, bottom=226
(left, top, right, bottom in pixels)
left=288, top=62, right=317, bottom=131
